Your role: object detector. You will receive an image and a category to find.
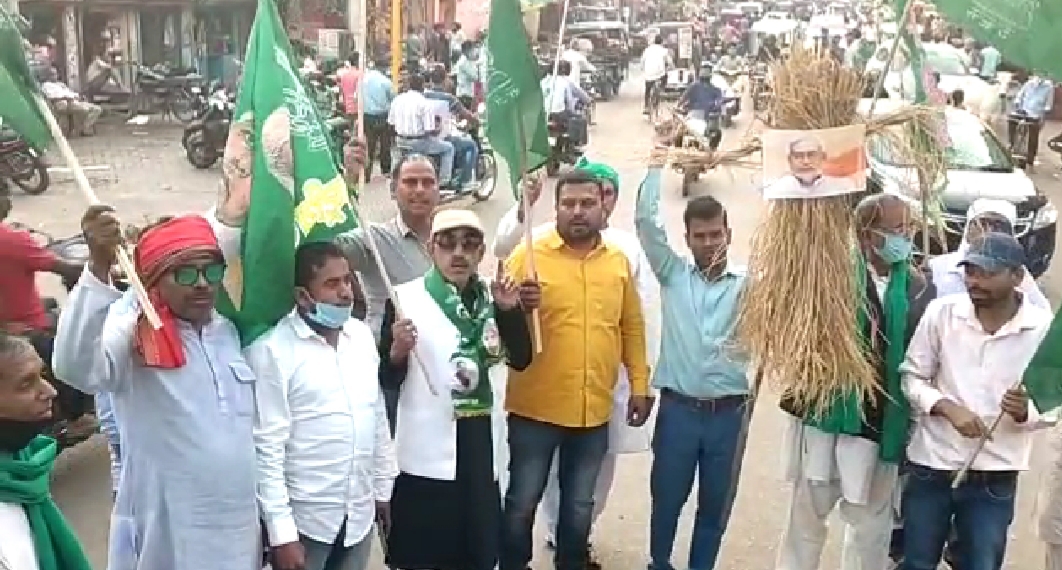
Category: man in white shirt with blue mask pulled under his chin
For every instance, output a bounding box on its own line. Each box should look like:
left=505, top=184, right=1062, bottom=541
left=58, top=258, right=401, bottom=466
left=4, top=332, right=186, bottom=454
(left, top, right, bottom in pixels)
left=246, top=242, right=398, bottom=570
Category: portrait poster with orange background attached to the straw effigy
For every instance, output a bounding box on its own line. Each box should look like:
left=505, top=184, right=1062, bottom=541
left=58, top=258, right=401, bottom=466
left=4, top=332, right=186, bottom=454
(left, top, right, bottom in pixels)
left=761, top=124, right=867, bottom=200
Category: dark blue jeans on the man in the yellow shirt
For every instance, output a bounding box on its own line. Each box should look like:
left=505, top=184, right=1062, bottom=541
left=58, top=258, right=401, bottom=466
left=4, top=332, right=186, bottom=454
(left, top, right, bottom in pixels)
left=500, top=414, right=609, bottom=570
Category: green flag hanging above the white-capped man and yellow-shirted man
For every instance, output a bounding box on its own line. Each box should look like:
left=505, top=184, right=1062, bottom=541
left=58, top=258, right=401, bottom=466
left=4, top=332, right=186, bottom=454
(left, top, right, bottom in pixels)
left=486, top=0, right=549, bottom=192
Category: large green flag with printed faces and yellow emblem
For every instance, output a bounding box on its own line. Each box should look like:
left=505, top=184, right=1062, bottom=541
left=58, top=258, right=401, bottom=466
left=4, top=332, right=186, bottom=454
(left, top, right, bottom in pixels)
left=219, top=0, right=357, bottom=345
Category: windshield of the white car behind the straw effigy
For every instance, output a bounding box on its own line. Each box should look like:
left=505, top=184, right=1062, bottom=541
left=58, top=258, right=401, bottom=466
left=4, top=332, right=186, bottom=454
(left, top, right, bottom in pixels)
left=868, top=114, right=1014, bottom=172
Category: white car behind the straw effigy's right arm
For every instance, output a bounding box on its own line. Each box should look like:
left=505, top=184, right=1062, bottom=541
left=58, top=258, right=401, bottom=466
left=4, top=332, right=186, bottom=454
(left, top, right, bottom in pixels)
left=860, top=99, right=1059, bottom=277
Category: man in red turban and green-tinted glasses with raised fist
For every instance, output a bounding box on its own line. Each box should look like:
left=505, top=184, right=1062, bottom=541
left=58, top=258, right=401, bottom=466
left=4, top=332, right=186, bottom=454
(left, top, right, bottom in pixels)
left=53, top=206, right=261, bottom=570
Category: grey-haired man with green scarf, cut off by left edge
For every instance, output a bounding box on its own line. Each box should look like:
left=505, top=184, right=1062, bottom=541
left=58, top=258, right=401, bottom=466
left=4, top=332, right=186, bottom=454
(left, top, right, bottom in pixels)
left=0, top=330, right=90, bottom=570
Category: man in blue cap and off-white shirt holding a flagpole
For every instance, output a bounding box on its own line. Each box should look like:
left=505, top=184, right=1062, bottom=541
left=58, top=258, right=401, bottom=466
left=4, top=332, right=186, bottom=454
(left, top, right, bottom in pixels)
left=901, top=232, right=1051, bottom=570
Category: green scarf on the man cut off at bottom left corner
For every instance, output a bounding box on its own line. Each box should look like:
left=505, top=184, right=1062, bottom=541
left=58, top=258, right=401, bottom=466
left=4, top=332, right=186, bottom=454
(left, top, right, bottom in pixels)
left=0, top=435, right=91, bottom=570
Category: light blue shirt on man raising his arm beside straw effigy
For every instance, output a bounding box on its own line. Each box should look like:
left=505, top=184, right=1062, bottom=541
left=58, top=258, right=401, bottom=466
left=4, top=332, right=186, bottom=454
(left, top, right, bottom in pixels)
left=634, top=168, right=749, bottom=398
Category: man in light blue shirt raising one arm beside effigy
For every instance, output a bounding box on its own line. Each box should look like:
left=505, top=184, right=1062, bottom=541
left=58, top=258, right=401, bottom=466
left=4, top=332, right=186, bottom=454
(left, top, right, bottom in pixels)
left=635, top=149, right=749, bottom=570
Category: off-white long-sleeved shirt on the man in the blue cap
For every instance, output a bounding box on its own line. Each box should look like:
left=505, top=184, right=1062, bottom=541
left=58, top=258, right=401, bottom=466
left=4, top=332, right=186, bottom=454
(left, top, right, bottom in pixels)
left=900, top=295, right=1051, bottom=471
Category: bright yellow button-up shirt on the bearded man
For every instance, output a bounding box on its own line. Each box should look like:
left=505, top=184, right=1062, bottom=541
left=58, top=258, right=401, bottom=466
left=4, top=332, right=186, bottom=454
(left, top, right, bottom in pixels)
left=506, top=229, right=649, bottom=428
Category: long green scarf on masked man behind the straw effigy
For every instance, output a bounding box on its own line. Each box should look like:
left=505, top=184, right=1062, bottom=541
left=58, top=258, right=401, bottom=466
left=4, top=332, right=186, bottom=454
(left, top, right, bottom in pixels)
left=804, top=255, right=910, bottom=463
